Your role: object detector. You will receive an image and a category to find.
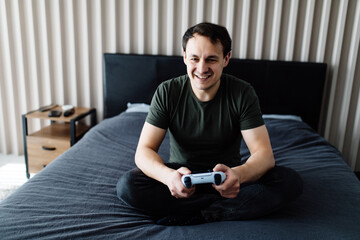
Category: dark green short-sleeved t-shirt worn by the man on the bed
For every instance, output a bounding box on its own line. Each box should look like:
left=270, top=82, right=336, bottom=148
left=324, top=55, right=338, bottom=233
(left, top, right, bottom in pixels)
left=146, top=74, right=264, bottom=170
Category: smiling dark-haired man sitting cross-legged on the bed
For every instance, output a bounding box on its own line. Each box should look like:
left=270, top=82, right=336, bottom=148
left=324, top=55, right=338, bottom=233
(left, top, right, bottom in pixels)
left=117, top=23, right=302, bottom=225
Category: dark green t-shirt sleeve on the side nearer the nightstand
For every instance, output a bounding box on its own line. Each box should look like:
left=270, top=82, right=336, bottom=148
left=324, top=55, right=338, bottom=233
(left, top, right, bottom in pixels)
left=146, top=84, right=170, bottom=129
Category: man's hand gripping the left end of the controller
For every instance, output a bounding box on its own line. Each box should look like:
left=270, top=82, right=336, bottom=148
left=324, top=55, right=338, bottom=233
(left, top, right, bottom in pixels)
left=166, top=167, right=195, bottom=198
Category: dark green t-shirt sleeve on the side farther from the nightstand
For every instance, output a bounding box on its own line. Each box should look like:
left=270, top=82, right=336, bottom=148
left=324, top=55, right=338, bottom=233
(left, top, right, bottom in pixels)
left=240, top=86, right=264, bottom=130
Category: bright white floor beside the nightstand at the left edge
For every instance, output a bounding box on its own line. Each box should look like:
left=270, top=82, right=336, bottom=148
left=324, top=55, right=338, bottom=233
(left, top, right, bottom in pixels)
left=0, top=154, right=28, bottom=201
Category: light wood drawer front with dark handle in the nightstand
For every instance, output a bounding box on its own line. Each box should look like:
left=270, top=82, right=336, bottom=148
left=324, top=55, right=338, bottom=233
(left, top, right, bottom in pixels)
left=26, top=136, right=70, bottom=173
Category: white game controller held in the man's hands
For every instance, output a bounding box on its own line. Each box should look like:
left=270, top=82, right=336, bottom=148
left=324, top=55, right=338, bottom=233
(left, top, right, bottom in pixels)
left=181, top=172, right=226, bottom=188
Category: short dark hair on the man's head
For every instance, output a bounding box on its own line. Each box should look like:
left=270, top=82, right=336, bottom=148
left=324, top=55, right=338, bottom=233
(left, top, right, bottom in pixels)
left=182, top=22, right=231, bottom=57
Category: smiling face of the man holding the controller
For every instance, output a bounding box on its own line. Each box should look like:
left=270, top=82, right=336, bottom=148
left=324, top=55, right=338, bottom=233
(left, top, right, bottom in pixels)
left=183, top=34, right=230, bottom=101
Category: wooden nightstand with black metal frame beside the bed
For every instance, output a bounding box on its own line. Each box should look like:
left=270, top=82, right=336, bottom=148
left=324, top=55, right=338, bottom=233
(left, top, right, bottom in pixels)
left=22, top=106, right=96, bottom=178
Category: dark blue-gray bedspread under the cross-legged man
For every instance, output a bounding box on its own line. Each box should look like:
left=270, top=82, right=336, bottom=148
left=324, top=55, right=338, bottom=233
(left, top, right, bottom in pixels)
left=0, top=113, right=360, bottom=240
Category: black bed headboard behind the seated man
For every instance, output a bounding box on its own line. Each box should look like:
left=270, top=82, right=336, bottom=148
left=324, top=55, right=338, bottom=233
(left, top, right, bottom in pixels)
left=104, top=54, right=326, bottom=130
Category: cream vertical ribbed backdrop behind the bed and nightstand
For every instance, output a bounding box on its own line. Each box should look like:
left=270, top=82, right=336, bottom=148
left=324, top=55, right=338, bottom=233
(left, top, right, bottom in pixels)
left=0, top=0, right=360, bottom=171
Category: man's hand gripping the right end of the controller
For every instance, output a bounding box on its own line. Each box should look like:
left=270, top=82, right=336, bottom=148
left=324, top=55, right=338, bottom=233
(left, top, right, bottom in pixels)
left=213, top=164, right=240, bottom=198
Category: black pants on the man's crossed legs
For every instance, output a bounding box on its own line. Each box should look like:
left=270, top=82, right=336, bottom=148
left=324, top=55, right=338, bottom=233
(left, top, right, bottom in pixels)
left=117, top=164, right=303, bottom=222
